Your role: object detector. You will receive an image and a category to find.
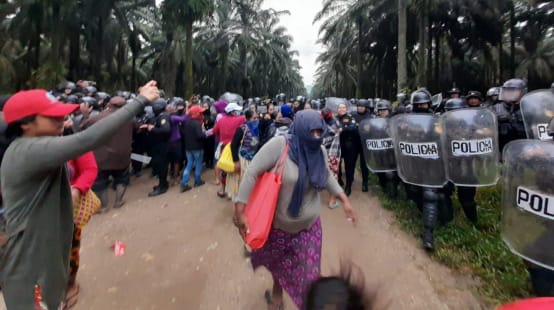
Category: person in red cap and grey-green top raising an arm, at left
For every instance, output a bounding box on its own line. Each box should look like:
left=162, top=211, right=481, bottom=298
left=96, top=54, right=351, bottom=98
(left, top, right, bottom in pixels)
left=0, top=81, right=159, bottom=309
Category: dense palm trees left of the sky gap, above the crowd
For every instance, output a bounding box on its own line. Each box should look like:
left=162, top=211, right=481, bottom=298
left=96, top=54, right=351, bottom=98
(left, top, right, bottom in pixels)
left=0, top=0, right=305, bottom=96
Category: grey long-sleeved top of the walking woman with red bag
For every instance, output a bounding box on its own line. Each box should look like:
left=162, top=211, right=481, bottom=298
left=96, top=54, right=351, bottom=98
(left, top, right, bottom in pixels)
left=235, top=137, right=343, bottom=233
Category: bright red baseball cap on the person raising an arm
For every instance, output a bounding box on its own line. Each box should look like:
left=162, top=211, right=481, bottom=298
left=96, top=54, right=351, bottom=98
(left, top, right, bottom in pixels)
left=4, top=89, right=79, bottom=125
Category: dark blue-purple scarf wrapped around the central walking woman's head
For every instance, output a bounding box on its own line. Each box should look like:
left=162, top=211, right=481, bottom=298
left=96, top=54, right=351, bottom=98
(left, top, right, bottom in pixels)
left=288, top=110, right=329, bottom=217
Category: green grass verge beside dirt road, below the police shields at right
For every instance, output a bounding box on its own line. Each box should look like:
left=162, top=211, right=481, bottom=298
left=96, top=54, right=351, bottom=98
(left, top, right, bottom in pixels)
left=372, top=177, right=531, bottom=306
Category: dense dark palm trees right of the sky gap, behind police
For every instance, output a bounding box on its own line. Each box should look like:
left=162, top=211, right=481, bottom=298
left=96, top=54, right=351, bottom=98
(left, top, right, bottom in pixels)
left=313, top=0, right=554, bottom=98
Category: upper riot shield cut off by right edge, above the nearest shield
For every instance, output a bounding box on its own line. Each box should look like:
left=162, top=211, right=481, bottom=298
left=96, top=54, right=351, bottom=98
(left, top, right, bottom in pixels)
left=520, top=89, right=554, bottom=141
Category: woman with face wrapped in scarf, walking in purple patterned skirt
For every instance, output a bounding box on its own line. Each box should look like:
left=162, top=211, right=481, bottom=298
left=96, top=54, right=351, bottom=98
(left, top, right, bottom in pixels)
left=233, top=110, right=356, bottom=309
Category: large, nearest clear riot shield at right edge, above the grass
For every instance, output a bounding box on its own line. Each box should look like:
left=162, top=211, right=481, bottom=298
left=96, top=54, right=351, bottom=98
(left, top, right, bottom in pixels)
left=502, top=140, right=554, bottom=270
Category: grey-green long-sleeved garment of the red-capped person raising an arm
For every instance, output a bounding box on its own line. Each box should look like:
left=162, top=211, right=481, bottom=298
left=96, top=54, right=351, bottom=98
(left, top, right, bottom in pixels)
left=0, top=96, right=148, bottom=310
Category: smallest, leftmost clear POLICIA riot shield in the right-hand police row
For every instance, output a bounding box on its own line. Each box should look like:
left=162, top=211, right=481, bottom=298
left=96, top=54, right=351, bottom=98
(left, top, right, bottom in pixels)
left=358, top=118, right=396, bottom=173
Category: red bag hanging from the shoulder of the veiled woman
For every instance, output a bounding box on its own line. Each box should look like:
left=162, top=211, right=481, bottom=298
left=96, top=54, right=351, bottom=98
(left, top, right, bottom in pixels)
left=244, top=144, right=289, bottom=250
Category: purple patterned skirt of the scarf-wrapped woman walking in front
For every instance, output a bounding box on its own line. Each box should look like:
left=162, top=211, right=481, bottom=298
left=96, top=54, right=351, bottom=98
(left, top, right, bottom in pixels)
left=252, top=218, right=322, bottom=309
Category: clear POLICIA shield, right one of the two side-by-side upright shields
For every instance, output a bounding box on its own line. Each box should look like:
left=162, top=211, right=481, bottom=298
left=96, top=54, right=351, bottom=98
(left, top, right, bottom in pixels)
left=440, top=108, right=500, bottom=186
